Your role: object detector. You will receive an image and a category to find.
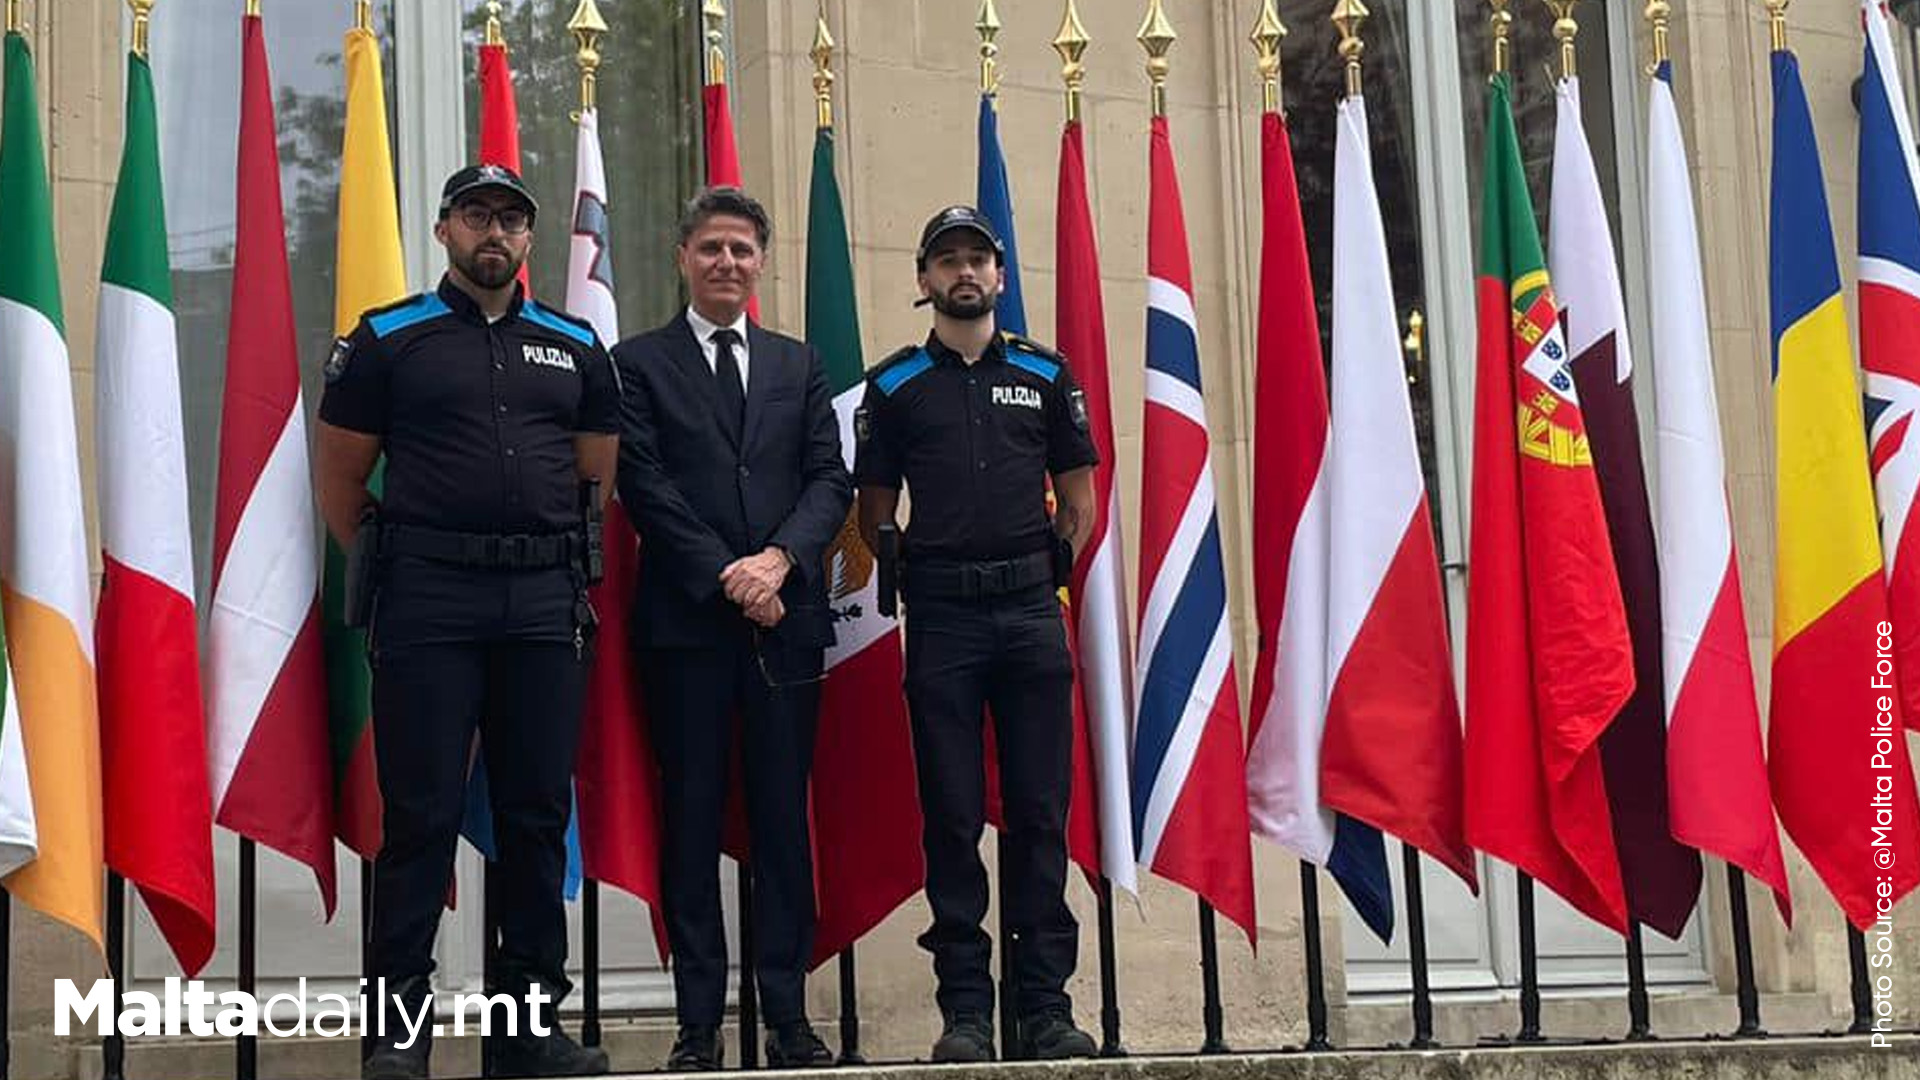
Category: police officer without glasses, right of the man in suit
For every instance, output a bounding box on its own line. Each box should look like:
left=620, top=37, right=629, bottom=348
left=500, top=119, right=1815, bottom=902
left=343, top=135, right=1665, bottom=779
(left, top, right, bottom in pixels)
left=854, top=206, right=1098, bottom=1061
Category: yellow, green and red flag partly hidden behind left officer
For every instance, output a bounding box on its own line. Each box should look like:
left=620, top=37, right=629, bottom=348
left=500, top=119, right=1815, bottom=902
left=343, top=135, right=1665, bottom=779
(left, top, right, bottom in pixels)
left=321, top=14, right=407, bottom=859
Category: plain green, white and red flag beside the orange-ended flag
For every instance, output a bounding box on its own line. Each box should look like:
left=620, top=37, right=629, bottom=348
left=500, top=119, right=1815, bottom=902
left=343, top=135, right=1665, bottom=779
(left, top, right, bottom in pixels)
left=94, top=42, right=213, bottom=976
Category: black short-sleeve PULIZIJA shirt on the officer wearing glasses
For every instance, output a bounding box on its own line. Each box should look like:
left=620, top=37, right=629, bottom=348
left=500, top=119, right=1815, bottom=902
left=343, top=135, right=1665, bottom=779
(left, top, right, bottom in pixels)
left=321, top=279, right=620, bottom=534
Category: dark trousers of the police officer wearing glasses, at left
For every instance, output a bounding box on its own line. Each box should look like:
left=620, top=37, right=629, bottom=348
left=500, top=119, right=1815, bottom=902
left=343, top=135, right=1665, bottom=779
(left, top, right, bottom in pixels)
left=367, top=642, right=588, bottom=992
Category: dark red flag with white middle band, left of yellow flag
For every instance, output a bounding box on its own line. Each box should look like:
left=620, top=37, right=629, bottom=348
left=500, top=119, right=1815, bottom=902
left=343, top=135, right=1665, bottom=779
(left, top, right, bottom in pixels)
left=207, top=15, right=334, bottom=919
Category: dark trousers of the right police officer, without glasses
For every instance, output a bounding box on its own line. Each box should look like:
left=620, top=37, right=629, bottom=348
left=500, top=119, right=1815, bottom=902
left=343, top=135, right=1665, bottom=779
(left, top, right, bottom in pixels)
left=906, top=586, right=1079, bottom=1017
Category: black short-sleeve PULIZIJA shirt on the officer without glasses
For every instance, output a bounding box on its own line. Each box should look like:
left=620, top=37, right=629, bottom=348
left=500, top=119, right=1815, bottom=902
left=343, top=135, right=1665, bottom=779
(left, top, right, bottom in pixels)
left=854, top=332, right=1100, bottom=559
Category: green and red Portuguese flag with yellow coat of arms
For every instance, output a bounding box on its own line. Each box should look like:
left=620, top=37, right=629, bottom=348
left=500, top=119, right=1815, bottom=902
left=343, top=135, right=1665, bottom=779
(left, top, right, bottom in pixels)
left=1467, top=75, right=1634, bottom=934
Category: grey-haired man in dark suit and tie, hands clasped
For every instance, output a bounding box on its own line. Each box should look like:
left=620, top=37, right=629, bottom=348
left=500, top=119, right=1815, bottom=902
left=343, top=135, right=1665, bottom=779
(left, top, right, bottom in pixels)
left=612, top=188, right=852, bottom=1070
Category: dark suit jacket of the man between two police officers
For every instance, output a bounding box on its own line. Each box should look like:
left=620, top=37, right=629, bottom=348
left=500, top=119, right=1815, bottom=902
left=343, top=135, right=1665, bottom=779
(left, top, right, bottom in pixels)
left=612, top=311, right=852, bottom=648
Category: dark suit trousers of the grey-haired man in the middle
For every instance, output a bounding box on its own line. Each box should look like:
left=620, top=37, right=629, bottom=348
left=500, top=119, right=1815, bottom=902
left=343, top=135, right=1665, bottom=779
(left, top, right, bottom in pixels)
left=641, top=623, right=822, bottom=1024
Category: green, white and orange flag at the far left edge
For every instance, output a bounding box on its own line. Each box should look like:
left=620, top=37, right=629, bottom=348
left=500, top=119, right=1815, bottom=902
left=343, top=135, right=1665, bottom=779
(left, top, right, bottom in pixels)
left=0, top=33, right=104, bottom=945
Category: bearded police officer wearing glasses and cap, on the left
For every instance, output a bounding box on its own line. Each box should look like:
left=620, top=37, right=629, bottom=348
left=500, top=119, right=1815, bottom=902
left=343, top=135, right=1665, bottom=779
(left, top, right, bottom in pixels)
left=317, top=165, right=620, bottom=1078
